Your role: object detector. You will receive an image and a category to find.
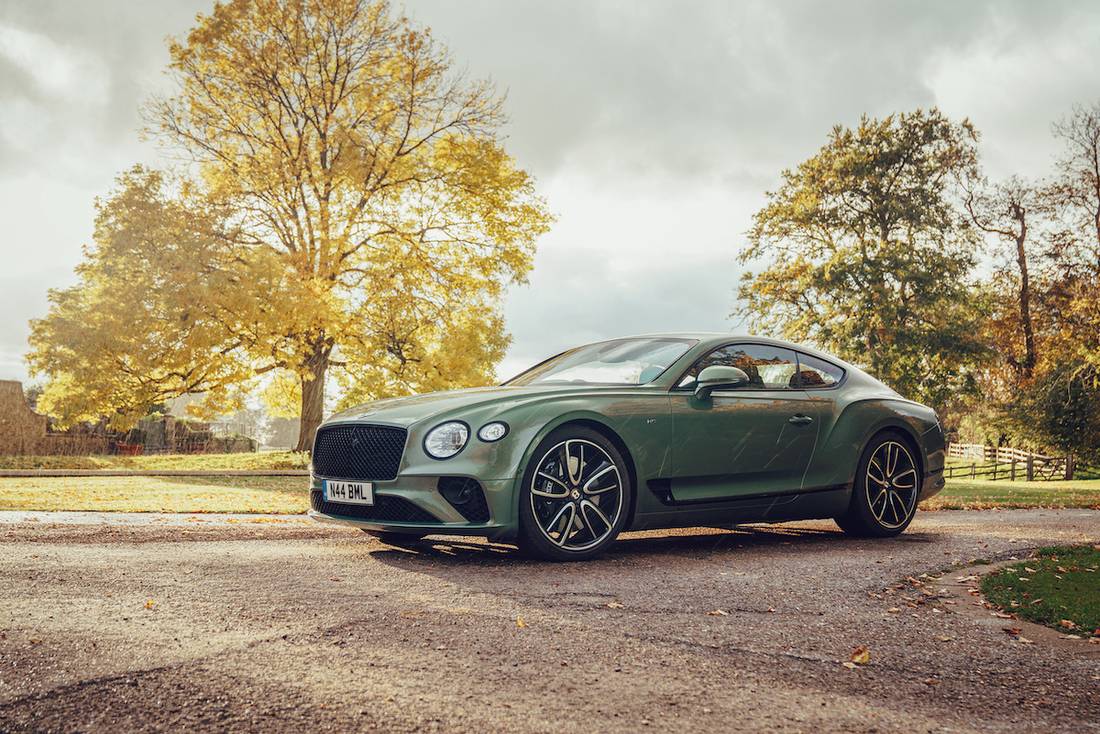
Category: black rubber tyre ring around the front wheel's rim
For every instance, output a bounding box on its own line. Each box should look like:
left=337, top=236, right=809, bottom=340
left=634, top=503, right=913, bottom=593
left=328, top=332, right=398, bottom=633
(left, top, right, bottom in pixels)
left=519, top=426, right=634, bottom=561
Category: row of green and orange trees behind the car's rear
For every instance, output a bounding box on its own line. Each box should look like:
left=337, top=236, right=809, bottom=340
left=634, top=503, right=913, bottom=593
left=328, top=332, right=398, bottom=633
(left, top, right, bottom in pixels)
left=736, top=103, right=1100, bottom=460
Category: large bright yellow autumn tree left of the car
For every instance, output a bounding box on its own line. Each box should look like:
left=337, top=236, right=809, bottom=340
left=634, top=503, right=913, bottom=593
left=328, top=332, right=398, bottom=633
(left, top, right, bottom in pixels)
left=30, top=0, right=551, bottom=448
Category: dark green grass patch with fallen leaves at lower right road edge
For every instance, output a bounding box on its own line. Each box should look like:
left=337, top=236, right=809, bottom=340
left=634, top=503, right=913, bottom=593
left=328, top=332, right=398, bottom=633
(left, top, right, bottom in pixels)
left=981, top=546, right=1100, bottom=637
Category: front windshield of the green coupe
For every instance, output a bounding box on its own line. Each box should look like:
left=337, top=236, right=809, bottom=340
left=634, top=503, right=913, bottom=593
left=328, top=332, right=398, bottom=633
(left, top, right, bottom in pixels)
left=505, top=337, right=695, bottom=385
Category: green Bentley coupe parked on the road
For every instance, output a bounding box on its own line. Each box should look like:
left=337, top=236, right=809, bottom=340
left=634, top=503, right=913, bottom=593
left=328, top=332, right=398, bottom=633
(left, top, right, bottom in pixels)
left=310, top=333, right=945, bottom=560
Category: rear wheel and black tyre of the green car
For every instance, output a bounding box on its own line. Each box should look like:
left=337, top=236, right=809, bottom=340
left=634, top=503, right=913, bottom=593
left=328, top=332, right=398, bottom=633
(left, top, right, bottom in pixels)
left=836, top=430, right=924, bottom=538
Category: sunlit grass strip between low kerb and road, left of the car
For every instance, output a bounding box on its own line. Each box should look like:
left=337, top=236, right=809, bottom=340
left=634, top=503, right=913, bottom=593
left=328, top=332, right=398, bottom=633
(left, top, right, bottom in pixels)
left=0, top=476, right=309, bottom=513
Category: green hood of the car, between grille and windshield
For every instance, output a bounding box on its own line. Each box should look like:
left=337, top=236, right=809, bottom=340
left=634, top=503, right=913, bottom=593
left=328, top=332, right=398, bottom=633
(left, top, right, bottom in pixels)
left=326, top=384, right=624, bottom=426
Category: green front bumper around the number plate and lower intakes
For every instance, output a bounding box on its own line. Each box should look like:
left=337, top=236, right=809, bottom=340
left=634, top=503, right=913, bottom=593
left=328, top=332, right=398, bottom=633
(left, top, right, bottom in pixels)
left=309, top=475, right=516, bottom=539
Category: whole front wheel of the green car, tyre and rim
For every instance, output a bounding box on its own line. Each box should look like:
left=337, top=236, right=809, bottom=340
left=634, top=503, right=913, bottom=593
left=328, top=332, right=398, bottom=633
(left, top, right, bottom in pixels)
left=518, top=426, right=634, bottom=561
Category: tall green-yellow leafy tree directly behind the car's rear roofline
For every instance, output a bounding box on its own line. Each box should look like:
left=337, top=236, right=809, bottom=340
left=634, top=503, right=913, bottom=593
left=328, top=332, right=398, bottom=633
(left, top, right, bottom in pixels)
left=736, top=109, right=985, bottom=418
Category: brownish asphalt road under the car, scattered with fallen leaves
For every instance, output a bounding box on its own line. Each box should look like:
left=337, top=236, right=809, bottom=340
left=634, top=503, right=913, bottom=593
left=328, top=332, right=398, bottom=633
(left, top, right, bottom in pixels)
left=0, top=511, right=1100, bottom=733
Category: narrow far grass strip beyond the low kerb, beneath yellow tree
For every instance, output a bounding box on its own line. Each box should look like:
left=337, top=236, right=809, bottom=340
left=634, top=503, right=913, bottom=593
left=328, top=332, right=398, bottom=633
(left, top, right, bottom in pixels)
left=0, top=451, right=309, bottom=471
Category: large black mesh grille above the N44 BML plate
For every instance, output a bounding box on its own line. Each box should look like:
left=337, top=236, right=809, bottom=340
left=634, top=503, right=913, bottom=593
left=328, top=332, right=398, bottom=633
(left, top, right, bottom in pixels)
left=314, top=425, right=406, bottom=481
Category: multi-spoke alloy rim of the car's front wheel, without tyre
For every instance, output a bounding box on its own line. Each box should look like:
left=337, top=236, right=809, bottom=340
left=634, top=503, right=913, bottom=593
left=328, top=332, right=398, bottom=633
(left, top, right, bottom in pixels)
left=530, top=438, right=624, bottom=551
